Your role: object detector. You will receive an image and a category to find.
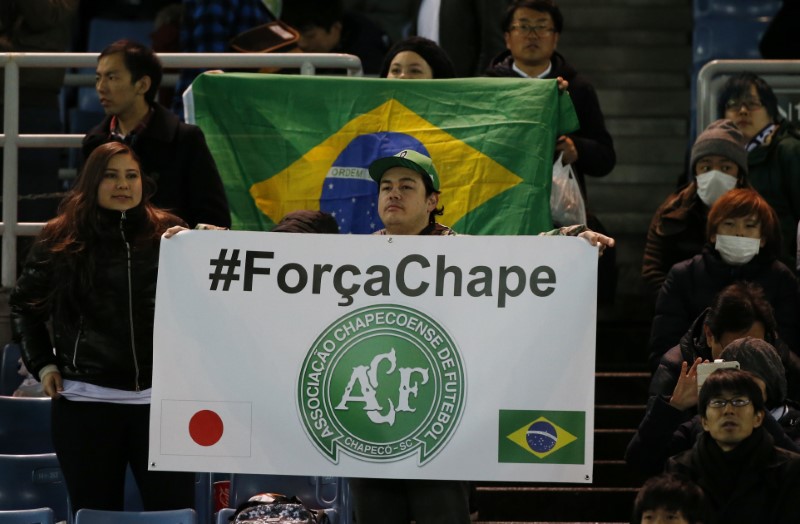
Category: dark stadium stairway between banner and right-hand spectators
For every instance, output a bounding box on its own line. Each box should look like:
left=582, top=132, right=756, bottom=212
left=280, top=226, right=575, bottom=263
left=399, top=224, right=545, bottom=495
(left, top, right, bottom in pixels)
left=477, top=0, right=692, bottom=524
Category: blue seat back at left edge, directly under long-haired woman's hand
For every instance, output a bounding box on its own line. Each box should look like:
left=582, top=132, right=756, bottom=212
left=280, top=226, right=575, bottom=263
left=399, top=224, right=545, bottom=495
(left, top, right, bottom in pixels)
left=0, top=396, right=54, bottom=455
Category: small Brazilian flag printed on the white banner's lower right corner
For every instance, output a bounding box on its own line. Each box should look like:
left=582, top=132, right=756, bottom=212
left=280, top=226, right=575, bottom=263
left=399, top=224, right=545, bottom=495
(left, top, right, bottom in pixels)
left=497, top=410, right=586, bottom=464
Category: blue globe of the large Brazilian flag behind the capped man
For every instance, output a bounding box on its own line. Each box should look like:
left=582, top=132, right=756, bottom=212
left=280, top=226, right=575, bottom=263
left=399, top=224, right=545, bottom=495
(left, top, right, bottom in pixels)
left=319, top=132, right=430, bottom=234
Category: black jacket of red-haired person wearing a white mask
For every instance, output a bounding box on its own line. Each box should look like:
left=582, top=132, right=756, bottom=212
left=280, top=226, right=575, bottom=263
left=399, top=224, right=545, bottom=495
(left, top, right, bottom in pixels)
left=650, top=245, right=800, bottom=362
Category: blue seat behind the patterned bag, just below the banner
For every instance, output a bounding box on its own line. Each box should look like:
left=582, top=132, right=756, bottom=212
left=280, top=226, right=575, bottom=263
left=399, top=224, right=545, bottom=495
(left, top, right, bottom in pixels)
left=229, top=474, right=351, bottom=524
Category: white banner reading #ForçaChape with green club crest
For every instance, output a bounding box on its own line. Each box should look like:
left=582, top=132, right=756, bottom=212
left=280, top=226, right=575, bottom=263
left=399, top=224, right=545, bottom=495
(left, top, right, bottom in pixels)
left=150, top=231, right=597, bottom=482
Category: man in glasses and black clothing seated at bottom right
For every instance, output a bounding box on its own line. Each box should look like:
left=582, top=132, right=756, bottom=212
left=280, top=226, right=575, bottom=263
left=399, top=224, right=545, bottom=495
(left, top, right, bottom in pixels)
left=667, top=369, right=800, bottom=524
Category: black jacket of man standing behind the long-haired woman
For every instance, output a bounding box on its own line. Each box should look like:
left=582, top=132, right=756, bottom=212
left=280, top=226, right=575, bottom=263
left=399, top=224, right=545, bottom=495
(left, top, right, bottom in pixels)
left=83, top=104, right=231, bottom=227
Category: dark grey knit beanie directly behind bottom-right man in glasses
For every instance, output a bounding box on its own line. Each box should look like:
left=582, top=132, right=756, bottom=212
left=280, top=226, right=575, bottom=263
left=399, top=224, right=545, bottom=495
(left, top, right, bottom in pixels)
left=720, top=337, right=786, bottom=408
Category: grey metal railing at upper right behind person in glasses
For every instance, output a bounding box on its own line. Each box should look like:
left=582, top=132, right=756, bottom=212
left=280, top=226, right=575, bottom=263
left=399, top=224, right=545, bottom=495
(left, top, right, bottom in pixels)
left=697, top=60, right=800, bottom=133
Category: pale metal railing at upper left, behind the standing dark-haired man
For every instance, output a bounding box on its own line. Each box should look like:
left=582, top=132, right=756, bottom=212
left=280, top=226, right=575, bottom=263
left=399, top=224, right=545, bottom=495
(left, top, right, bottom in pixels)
left=0, top=53, right=363, bottom=288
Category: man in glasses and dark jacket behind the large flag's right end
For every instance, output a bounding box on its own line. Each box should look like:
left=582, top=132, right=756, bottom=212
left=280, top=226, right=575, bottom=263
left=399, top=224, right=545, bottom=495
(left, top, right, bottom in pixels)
left=486, top=0, right=617, bottom=302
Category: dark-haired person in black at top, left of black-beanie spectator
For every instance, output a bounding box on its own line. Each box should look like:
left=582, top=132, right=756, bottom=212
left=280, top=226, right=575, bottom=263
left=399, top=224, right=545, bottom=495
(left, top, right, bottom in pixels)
left=281, top=0, right=389, bottom=75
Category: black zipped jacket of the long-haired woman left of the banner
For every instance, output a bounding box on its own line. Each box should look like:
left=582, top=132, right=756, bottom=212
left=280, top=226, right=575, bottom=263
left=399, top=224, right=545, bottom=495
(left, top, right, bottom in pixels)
left=9, top=207, right=184, bottom=391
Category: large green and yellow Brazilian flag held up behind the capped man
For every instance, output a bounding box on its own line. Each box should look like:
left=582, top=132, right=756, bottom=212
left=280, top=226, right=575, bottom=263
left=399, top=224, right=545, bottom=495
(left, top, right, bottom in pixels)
left=192, top=73, right=578, bottom=235
